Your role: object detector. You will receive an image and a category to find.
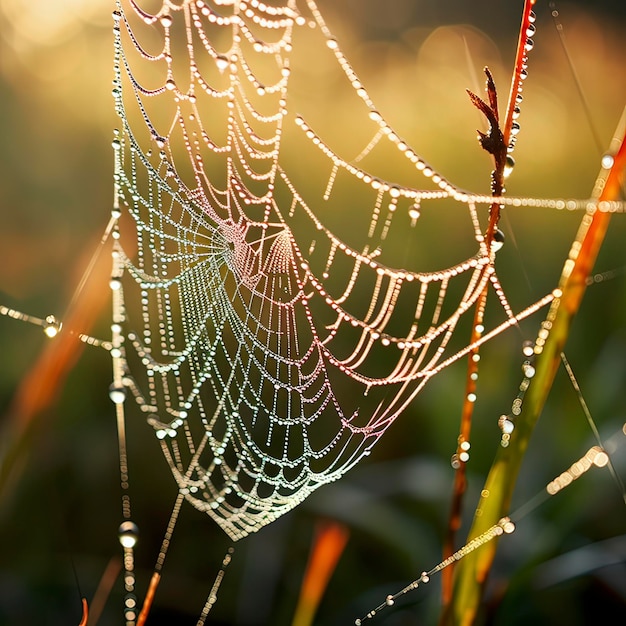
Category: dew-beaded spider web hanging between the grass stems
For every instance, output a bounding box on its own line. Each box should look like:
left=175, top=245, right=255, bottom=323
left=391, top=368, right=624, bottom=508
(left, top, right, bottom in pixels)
left=111, top=0, right=554, bottom=540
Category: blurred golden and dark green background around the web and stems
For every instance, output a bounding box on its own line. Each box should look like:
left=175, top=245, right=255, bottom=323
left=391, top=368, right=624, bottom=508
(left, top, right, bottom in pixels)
left=0, top=0, right=626, bottom=626
